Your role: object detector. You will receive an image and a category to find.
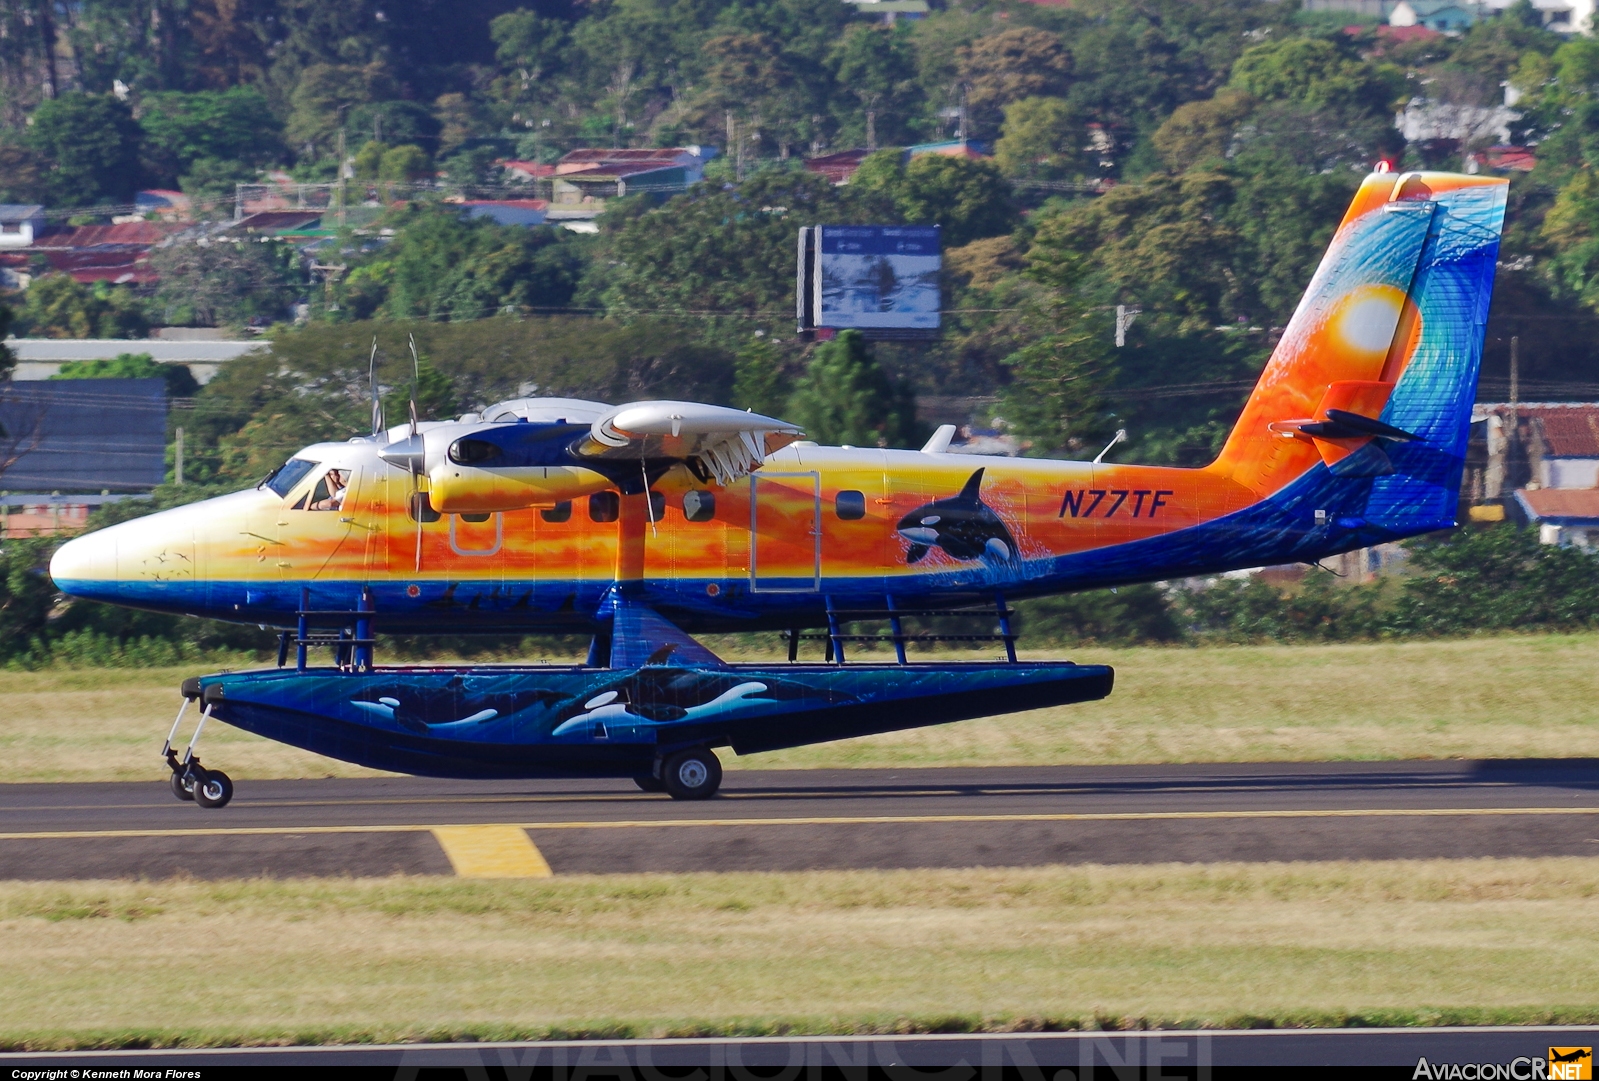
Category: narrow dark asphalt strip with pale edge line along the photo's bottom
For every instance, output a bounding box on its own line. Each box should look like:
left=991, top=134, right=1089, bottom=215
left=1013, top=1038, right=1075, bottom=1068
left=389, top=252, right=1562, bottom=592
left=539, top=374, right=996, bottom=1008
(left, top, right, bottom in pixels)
left=0, top=1025, right=1599, bottom=1081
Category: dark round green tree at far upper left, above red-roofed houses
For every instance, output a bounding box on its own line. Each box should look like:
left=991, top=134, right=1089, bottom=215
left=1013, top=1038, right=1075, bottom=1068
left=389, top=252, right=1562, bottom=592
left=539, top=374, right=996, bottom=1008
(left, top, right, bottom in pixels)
left=27, top=91, right=141, bottom=206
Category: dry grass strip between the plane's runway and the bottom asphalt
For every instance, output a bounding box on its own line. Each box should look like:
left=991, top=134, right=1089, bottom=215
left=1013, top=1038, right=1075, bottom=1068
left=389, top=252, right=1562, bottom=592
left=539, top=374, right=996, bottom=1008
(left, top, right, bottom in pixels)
left=0, top=859, right=1599, bottom=1049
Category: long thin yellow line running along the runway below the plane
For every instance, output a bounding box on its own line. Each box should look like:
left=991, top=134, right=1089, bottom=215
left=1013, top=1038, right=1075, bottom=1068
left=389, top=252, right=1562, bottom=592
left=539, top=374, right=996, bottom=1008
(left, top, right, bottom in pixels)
left=0, top=808, right=1599, bottom=844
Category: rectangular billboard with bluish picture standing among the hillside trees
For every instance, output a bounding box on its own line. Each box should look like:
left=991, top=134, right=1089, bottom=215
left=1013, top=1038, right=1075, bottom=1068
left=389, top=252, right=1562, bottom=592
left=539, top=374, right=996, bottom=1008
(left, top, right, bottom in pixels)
left=800, top=225, right=942, bottom=336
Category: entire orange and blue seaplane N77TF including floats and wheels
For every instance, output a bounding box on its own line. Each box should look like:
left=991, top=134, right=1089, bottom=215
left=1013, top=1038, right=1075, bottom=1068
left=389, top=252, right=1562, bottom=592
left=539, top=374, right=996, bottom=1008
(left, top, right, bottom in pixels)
left=51, top=171, right=1506, bottom=806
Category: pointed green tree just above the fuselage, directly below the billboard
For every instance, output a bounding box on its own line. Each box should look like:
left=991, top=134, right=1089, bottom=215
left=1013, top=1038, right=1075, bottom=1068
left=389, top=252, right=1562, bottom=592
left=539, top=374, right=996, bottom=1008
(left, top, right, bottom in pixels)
left=785, top=331, right=916, bottom=446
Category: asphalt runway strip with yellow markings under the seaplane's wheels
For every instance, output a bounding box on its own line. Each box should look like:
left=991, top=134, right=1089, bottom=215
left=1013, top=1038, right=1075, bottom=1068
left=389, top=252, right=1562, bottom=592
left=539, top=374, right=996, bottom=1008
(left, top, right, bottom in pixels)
left=0, top=760, right=1599, bottom=880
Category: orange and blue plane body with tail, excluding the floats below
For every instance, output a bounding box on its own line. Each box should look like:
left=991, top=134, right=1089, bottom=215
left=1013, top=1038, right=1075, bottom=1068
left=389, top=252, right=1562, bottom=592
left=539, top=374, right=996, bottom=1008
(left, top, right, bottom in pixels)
left=51, top=173, right=1505, bottom=633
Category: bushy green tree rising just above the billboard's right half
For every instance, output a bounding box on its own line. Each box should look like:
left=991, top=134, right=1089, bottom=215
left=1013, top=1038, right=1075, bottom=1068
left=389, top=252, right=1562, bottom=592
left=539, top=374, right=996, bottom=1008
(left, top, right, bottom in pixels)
left=849, top=150, right=1017, bottom=248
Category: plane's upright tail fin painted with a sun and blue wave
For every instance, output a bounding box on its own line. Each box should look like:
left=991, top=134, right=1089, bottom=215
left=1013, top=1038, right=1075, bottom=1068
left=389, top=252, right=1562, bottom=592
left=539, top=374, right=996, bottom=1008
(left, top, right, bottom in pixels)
left=1209, top=173, right=1506, bottom=529
